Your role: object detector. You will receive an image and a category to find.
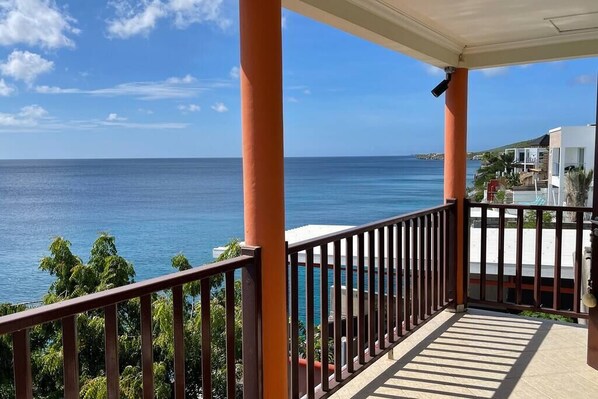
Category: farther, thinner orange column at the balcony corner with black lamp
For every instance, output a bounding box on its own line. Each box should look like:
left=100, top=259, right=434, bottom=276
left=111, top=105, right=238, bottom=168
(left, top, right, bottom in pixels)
left=444, top=68, right=468, bottom=308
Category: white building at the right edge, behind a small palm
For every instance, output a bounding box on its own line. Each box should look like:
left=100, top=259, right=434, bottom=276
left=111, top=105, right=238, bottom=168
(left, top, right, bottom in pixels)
left=548, top=125, right=596, bottom=206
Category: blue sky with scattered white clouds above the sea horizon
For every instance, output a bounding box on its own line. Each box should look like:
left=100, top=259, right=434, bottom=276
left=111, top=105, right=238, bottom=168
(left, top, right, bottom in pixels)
left=0, top=0, right=598, bottom=159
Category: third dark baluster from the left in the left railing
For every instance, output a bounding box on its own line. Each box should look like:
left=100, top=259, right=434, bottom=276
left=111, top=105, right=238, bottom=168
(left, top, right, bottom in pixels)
left=104, top=305, right=120, bottom=399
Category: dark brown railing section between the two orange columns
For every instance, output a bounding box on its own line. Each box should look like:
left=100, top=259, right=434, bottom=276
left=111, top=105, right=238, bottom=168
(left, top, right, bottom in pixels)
left=287, top=203, right=456, bottom=398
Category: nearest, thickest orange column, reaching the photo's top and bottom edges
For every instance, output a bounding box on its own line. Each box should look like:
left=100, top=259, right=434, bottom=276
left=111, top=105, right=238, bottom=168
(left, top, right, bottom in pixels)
left=239, top=0, right=288, bottom=399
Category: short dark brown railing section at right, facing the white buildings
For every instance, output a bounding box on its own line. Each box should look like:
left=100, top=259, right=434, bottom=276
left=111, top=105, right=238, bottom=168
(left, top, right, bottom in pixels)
left=465, top=202, right=592, bottom=318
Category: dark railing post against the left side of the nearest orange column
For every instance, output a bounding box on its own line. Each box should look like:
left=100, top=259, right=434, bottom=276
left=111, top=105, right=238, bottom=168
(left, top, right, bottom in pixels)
left=241, top=247, right=263, bottom=398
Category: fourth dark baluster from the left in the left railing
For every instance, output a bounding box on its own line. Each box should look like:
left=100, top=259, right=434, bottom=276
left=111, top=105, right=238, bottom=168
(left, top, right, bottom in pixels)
left=140, top=295, right=154, bottom=399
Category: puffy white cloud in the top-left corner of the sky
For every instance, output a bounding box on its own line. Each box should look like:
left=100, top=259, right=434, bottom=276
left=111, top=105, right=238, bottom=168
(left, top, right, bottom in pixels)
left=0, top=0, right=79, bottom=49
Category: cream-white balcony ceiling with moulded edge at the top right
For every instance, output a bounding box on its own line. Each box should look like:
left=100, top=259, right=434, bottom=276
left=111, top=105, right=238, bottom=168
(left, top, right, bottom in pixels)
left=283, top=0, right=598, bottom=69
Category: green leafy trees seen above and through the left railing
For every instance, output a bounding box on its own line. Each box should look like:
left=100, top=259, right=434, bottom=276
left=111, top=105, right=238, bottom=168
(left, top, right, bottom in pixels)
left=0, top=234, right=242, bottom=399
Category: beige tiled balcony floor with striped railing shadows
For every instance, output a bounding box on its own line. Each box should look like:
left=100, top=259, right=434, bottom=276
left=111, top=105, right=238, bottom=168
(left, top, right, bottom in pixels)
left=332, top=309, right=598, bottom=399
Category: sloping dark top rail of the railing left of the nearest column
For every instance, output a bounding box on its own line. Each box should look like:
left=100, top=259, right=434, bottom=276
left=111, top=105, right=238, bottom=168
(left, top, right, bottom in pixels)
left=0, top=255, right=254, bottom=335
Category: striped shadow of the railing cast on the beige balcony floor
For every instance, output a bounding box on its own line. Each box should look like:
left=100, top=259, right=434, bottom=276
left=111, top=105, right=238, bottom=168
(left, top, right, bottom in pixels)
left=353, top=312, right=553, bottom=399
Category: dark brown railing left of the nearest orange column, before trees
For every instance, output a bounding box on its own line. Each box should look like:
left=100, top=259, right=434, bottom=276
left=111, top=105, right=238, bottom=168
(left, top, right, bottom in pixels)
left=0, top=248, right=261, bottom=399
